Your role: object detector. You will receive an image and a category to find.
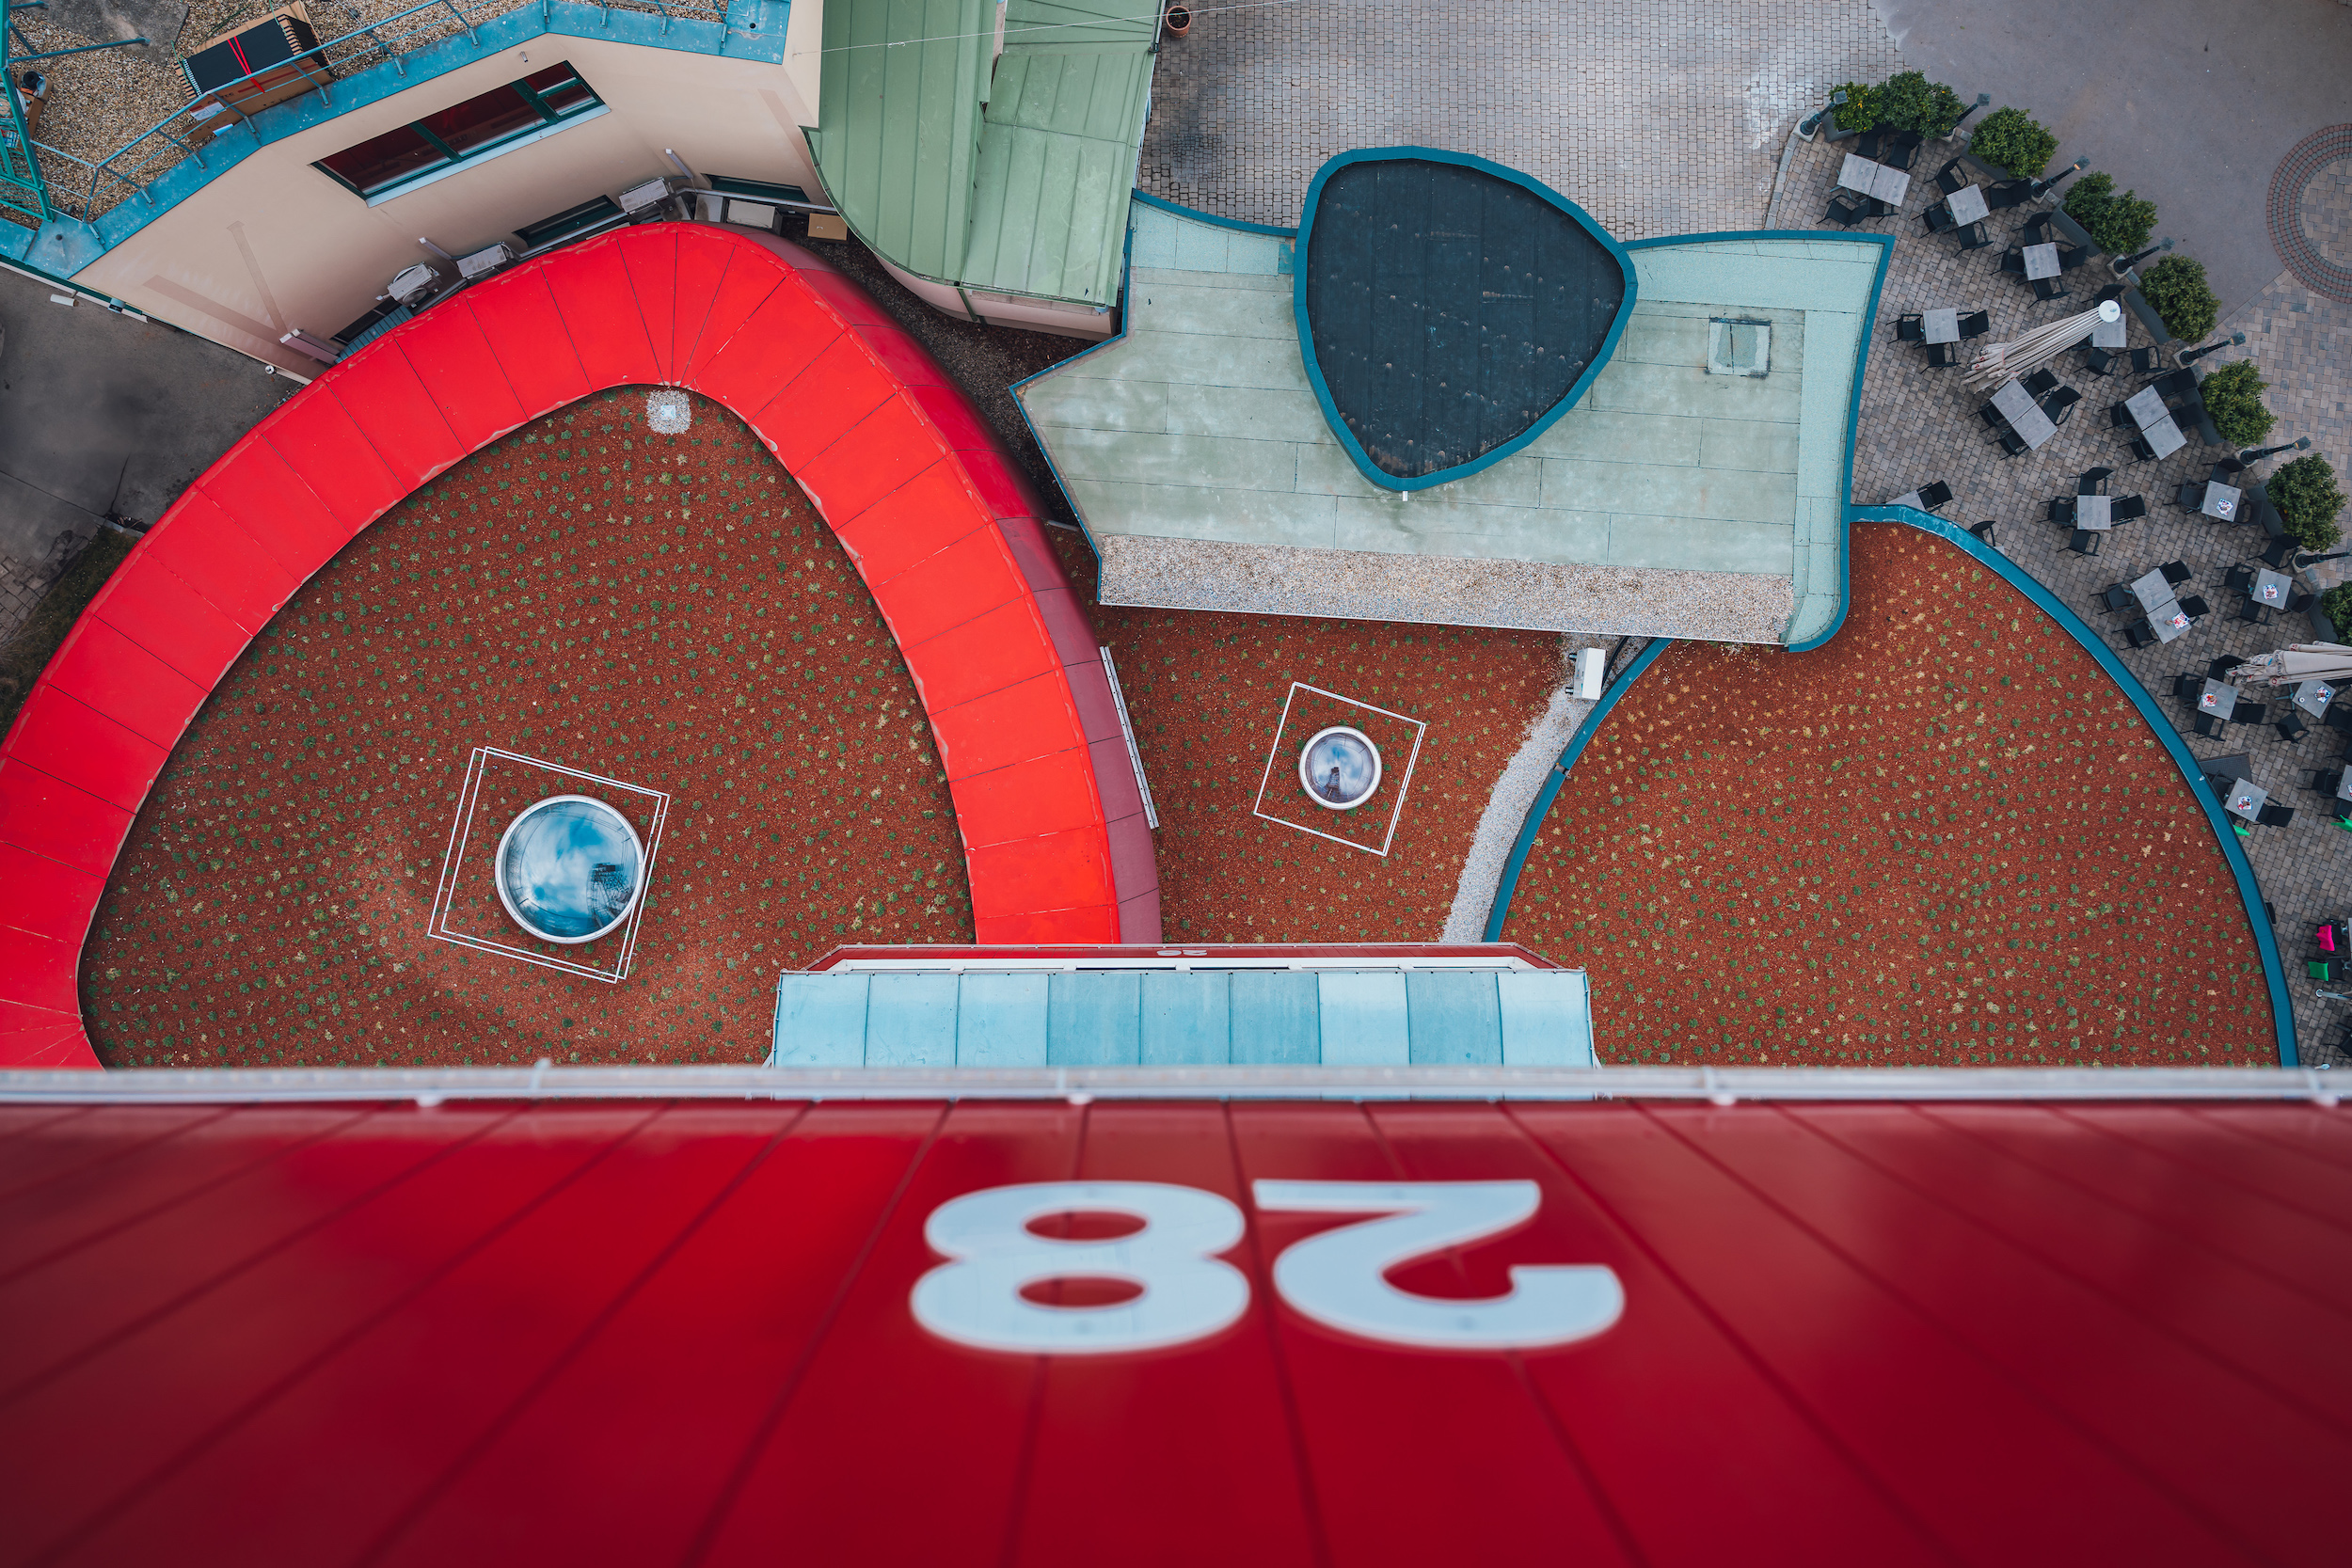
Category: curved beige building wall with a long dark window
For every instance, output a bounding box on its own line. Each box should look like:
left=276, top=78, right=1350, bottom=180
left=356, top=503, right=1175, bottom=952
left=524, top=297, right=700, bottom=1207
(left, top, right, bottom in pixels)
left=75, top=39, right=823, bottom=376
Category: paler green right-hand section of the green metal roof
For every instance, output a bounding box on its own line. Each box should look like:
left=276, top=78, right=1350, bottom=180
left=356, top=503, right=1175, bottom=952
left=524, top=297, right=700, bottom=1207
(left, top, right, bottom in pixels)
left=962, top=51, right=1152, bottom=306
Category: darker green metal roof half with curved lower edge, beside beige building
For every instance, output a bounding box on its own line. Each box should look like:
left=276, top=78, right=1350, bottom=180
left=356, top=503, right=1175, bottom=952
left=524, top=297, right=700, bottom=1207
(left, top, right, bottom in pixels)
left=817, top=0, right=997, bottom=279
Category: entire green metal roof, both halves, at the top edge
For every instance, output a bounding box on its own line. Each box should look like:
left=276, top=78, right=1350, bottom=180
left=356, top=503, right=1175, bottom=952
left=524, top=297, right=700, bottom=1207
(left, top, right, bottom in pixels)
left=817, top=0, right=1157, bottom=306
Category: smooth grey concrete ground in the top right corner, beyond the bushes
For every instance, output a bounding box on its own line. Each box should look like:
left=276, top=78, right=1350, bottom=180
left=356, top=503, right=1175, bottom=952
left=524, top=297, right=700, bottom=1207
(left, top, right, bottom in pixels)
left=1872, top=0, right=2352, bottom=312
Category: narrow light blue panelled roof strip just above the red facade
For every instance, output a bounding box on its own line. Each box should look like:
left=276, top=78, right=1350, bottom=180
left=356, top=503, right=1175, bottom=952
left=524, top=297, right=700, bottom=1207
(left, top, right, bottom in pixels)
left=770, top=969, right=1593, bottom=1068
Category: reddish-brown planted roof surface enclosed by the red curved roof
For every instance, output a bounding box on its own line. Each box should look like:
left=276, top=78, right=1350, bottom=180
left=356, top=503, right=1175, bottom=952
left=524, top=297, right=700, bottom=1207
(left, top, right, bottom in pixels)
left=83, top=388, right=972, bottom=1068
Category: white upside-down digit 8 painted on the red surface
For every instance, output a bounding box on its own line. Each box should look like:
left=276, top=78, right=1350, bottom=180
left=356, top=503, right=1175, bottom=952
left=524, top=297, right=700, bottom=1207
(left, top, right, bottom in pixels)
left=913, top=1182, right=1249, bottom=1356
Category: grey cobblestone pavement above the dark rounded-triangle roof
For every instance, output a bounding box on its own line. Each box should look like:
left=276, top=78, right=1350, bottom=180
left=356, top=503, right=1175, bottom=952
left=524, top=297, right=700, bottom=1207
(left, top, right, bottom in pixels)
left=1141, top=0, right=1900, bottom=240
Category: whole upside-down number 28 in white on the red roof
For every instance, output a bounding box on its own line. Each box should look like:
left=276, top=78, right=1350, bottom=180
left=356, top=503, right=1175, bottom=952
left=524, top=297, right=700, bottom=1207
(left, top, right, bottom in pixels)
left=913, top=1182, right=1626, bottom=1356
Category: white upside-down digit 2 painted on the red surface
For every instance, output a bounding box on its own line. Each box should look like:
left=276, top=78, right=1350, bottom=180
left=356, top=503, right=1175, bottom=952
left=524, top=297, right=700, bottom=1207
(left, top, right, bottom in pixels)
left=1254, top=1182, right=1626, bottom=1350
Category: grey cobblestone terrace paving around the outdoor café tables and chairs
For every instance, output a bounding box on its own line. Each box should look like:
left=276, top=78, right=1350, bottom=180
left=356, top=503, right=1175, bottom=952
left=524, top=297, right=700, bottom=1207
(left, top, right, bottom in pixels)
left=1781, top=143, right=2352, bottom=1063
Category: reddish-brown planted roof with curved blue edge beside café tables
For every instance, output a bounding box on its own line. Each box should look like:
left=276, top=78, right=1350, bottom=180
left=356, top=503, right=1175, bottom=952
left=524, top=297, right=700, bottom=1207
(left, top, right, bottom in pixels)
left=1503, top=524, right=2277, bottom=1068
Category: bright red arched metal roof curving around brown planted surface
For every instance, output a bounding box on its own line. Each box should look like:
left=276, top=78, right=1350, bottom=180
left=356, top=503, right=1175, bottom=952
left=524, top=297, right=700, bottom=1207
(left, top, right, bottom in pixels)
left=0, top=223, right=1160, bottom=1068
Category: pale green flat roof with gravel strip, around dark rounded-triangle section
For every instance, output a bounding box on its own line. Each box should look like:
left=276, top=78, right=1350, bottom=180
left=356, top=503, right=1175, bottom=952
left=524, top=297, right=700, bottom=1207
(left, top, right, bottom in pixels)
left=1019, top=202, right=1882, bottom=641
